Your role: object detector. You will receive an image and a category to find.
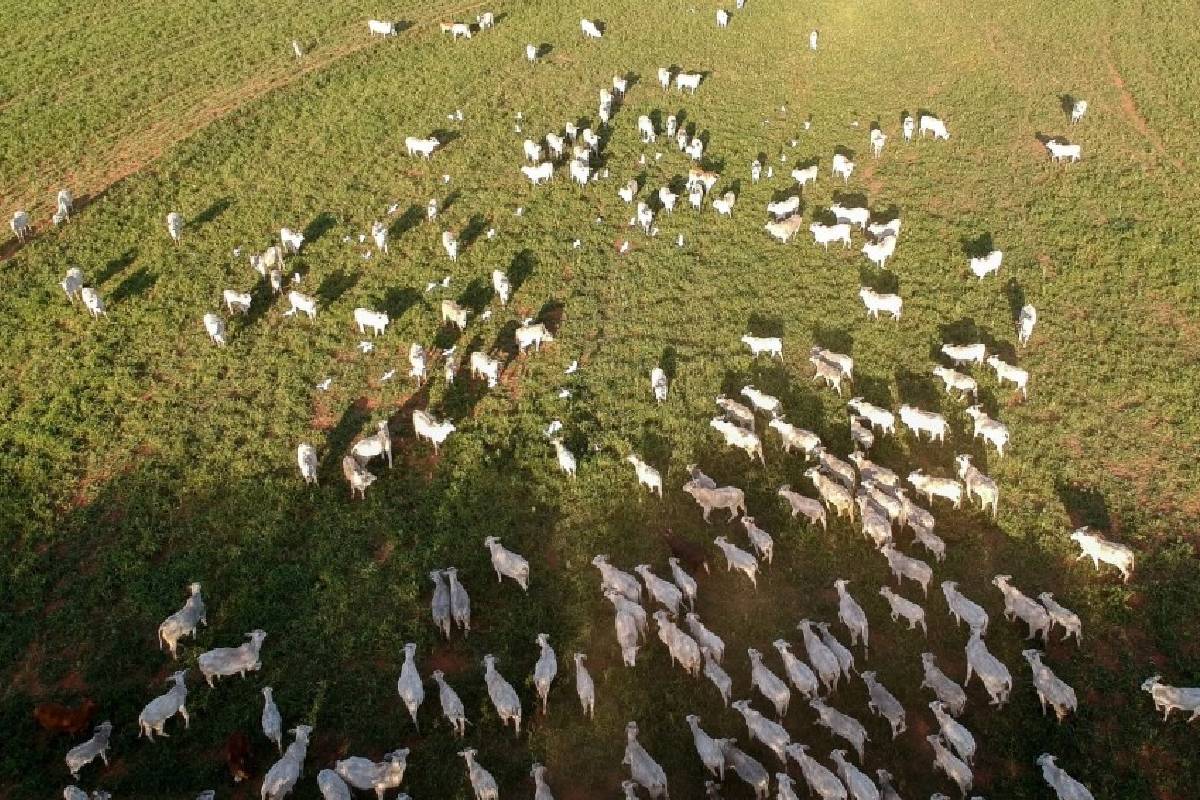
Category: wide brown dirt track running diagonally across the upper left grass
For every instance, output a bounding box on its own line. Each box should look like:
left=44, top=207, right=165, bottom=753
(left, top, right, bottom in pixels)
left=0, top=1, right=486, bottom=261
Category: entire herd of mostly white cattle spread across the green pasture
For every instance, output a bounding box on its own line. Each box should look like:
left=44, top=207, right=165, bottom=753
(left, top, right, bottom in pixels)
left=11, top=0, right=1200, bottom=800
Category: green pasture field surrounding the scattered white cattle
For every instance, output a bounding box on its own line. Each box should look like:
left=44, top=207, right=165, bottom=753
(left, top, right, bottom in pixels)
left=0, top=0, right=1200, bottom=800
